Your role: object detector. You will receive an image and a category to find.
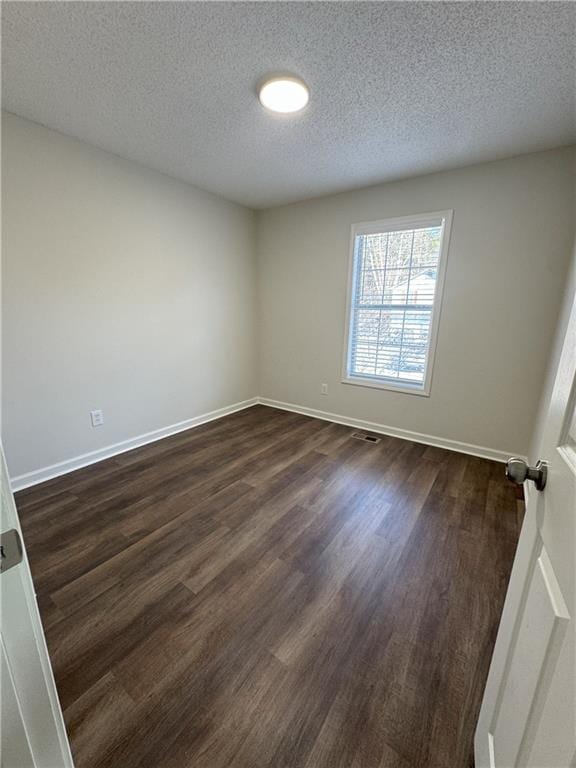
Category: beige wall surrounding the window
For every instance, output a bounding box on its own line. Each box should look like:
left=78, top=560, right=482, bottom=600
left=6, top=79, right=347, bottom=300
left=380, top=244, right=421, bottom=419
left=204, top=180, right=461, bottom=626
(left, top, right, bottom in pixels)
left=257, top=148, right=574, bottom=454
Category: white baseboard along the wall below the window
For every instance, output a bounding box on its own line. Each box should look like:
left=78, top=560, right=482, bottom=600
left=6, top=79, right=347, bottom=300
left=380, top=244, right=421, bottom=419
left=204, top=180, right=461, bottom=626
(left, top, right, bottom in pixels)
left=259, top=397, right=524, bottom=462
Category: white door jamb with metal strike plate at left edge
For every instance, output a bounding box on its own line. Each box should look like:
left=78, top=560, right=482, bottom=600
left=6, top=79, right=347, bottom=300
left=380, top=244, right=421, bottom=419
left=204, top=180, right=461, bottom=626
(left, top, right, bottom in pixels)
left=0, top=445, right=73, bottom=768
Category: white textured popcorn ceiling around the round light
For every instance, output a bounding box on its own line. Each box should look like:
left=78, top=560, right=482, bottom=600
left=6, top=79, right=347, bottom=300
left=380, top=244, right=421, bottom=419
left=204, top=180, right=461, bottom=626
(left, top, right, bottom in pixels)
left=2, top=2, right=576, bottom=208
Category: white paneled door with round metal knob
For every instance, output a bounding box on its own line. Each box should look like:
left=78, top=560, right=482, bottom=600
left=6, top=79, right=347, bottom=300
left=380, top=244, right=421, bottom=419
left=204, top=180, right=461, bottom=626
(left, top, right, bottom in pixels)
left=475, top=284, right=576, bottom=768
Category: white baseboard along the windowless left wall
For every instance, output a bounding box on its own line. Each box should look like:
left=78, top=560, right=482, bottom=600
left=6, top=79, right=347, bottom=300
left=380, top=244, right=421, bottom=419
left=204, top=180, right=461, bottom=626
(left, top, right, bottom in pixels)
left=10, top=397, right=259, bottom=492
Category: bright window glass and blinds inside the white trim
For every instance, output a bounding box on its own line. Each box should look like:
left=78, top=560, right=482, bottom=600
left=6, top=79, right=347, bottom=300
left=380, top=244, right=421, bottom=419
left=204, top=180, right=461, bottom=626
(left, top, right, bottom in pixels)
left=348, top=220, right=442, bottom=386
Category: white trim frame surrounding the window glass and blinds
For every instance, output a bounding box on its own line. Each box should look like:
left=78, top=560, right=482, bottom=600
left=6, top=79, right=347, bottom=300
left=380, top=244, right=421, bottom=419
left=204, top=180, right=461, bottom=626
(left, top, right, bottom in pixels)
left=341, top=210, right=453, bottom=397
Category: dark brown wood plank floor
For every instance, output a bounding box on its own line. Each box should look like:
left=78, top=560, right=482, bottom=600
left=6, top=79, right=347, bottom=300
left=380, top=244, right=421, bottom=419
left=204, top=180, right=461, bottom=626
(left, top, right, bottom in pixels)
left=17, top=406, right=523, bottom=768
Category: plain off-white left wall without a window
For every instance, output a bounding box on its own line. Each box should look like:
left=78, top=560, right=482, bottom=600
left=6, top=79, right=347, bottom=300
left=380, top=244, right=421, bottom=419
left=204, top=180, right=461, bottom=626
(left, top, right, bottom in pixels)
left=2, top=115, right=257, bottom=476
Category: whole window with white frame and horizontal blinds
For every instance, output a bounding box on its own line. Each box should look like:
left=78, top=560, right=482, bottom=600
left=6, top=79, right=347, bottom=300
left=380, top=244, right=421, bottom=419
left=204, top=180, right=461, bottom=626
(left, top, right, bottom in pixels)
left=343, top=211, right=452, bottom=395
